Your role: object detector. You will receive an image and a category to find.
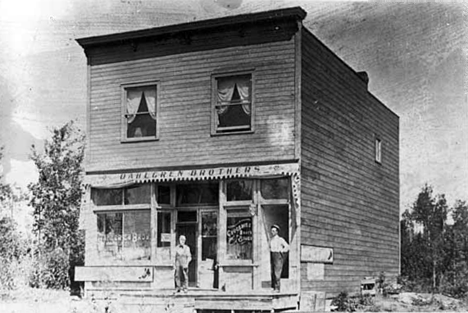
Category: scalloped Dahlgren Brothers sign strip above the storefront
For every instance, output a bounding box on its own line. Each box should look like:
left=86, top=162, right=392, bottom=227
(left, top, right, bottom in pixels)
left=84, top=163, right=299, bottom=187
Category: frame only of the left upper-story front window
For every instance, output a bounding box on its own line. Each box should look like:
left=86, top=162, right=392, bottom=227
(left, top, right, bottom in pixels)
left=120, top=80, right=161, bottom=142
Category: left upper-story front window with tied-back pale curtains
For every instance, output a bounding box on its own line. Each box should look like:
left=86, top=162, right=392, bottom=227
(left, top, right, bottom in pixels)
left=122, top=83, right=158, bottom=141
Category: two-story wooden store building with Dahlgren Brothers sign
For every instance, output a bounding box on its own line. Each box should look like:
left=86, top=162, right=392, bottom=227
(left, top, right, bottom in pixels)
left=76, top=7, right=399, bottom=312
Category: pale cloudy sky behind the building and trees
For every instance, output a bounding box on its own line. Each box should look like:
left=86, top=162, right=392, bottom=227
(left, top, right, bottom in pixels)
left=0, top=0, right=468, bottom=211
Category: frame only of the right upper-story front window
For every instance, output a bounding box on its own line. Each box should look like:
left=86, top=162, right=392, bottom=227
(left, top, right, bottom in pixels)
left=211, top=69, right=255, bottom=136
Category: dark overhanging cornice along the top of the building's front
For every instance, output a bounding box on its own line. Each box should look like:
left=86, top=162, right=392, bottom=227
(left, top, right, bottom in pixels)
left=76, top=7, right=307, bottom=49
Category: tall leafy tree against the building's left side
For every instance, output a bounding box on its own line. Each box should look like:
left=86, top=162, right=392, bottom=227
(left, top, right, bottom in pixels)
left=28, top=122, right=84, bottom=288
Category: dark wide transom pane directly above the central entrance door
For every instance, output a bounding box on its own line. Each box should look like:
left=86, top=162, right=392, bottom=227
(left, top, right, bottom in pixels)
left=176, top=182, right=219, bottom=205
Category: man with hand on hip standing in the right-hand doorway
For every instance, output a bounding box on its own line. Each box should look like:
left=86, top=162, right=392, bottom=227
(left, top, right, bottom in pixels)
left=270, top=224, right=289, bottom=292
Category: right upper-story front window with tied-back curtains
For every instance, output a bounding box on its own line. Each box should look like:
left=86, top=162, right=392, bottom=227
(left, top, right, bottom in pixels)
left=212, top=73, right=253, bottom=134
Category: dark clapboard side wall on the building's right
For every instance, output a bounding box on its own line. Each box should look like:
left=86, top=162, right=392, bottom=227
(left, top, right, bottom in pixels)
left=301, top=30, right=399, bottom=294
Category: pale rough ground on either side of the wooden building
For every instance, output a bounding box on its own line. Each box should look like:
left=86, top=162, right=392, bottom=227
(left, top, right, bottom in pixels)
left=0, top=288, right=468, bottom=313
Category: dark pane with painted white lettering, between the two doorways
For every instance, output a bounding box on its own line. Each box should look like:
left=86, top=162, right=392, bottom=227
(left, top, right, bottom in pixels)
left=226, top=213, right=253, bottom=260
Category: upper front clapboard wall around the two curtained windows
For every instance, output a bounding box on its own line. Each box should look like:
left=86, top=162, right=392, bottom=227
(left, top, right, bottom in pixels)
left=86, top=23, right=297, bottom=172
